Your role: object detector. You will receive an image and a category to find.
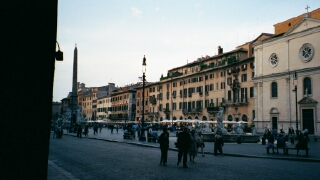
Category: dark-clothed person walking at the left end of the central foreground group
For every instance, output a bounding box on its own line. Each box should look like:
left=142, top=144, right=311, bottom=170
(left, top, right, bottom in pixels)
left=158, top=127, right=169, bottom=165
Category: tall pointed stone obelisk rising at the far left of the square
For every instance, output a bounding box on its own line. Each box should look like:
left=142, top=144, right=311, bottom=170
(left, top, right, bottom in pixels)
left=71, top=44, right=78, bottom=124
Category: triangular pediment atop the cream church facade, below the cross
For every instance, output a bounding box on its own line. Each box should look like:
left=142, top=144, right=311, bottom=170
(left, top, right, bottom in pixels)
left=284, top=18, right=320, bottom=36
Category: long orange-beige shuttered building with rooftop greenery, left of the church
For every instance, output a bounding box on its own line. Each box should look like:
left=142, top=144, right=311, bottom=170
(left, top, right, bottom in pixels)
left=137, top=33, right=272, bottom=128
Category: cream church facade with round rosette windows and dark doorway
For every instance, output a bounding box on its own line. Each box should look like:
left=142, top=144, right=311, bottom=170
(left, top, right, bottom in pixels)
left=254, top=9, right=320, bottom=134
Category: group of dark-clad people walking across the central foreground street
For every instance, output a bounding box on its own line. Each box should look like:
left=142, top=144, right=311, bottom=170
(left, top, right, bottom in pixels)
left=158, top=127, right=224, bottom=168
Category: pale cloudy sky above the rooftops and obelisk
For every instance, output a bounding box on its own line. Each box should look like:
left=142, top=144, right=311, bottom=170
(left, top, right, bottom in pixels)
left=53, top=0, right=320, bottom=101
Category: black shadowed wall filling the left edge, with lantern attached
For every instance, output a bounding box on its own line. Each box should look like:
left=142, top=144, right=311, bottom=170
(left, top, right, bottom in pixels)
left=0, top=0, right=58, bottom=179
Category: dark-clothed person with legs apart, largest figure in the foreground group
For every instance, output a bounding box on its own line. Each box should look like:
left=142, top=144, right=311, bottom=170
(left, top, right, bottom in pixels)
left=177, top=127, right=191, bottom=168
